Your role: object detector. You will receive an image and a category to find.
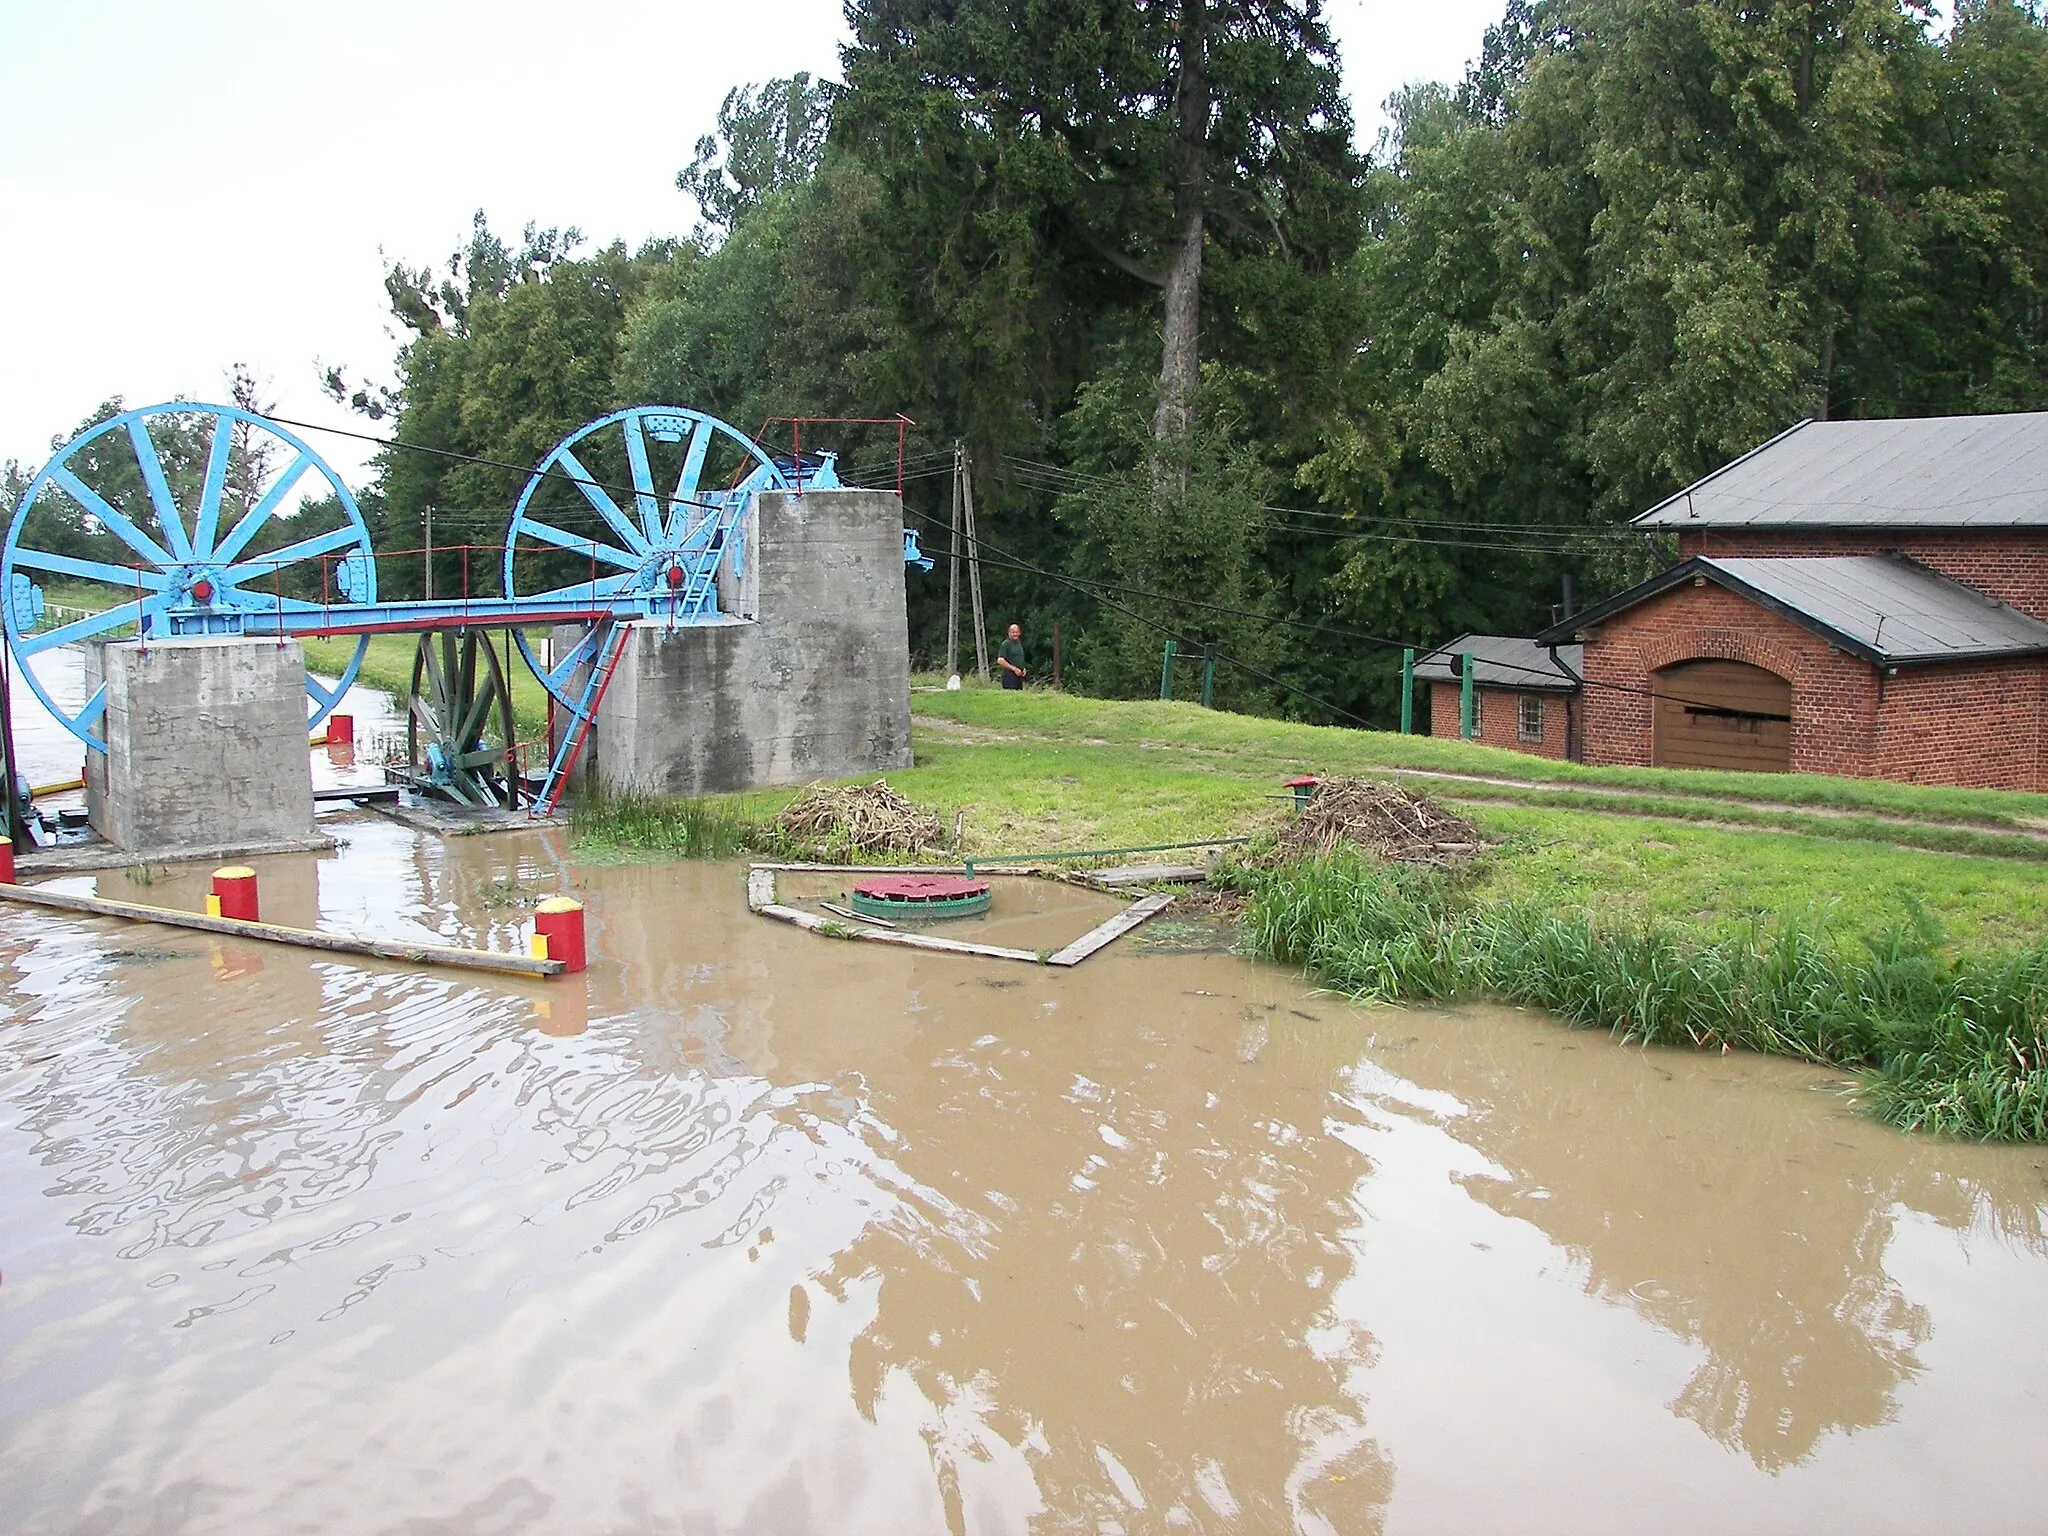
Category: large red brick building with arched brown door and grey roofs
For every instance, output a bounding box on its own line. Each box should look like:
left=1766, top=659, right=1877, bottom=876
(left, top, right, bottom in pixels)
left=1538, top=414, right=2048, bottom=791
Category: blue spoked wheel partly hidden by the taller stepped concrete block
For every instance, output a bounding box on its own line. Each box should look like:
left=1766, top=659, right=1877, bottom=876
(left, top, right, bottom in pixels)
left=504, top=406, right=791, bottom=721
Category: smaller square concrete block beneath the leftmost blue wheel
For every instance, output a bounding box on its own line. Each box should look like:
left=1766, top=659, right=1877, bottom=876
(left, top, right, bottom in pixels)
left=86, top=639, right=313, bottom=858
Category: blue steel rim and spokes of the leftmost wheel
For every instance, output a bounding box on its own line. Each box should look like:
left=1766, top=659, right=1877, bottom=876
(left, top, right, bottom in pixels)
left=0, top=399, right=377, bottom=752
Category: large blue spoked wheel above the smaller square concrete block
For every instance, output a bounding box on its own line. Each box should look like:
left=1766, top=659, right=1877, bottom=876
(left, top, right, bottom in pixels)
left=0, top=399, right=377, bottom=752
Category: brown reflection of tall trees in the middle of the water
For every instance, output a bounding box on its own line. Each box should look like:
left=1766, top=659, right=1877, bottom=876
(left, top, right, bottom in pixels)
left=819, top=961, right=1391, bottom=1530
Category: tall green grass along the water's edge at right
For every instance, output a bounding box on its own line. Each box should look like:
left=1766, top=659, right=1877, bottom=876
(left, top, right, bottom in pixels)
left=1245, top=854, right=2048, bottom=1141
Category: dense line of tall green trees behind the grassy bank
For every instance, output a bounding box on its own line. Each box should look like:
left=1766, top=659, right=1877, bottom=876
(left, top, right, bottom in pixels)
left=303, top=0, right=2048, bottom=721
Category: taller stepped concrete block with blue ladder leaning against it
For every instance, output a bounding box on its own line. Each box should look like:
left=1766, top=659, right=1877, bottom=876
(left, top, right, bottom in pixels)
left=586, top=492, right=909, bottom=795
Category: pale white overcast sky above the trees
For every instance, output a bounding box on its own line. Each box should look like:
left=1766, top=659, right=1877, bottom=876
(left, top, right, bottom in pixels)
left=0, top=0, right=1503, bottom=489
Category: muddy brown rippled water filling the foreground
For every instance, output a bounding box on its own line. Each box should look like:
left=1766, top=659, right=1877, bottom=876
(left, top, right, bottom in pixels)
left=0, top=819, right=2048, bottom=1536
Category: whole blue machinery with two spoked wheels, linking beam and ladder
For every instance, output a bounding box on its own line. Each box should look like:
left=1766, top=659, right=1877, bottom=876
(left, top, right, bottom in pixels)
left=0, top=401, right=932, bottom=811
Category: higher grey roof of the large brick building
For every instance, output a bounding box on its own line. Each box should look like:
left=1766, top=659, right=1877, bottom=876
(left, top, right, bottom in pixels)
left=1632, top=412, right=2048, bottom=528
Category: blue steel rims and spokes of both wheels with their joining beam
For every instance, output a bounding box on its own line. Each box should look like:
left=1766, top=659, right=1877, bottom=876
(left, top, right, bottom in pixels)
left=0, top=401, right=932, bottom=761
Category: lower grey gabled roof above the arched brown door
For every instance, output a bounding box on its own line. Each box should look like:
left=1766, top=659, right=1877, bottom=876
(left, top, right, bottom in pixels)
left=1538, top=555, right=2048, bottom=666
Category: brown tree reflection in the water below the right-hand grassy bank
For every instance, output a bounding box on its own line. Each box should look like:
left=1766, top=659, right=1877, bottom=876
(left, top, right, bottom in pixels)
left=1327, top=1014, right=2048, bottom=1470
